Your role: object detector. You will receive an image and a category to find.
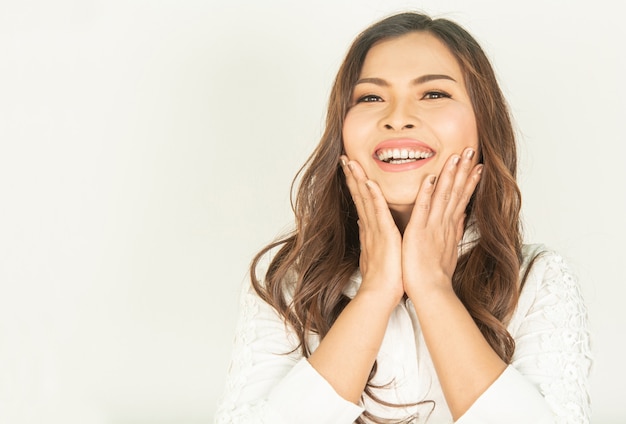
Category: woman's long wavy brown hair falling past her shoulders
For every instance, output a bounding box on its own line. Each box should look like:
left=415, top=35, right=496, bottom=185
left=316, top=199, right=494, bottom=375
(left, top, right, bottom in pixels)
left=250, top=13, right=522, bottom=420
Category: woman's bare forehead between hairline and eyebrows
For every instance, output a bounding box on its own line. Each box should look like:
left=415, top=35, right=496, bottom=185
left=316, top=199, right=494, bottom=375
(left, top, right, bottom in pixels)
left=361, top=32, right=463, bottom=81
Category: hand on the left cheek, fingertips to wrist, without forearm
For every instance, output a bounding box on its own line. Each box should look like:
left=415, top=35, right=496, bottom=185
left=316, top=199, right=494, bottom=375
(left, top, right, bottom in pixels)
left=341, top=156, right=404, bottom=308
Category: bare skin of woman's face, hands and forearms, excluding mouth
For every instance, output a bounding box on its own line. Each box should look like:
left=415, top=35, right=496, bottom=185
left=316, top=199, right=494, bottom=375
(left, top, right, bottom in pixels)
left=309, top=32, right=506, bottom=420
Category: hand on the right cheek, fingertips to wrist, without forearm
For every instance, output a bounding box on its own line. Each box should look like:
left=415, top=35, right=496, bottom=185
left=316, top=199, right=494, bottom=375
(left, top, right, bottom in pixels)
left=402, top=148, right=483, bottom=299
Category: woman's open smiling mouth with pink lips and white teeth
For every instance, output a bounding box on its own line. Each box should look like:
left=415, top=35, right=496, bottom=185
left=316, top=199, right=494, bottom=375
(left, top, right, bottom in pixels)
left=372, top=139, right=436, bottom=172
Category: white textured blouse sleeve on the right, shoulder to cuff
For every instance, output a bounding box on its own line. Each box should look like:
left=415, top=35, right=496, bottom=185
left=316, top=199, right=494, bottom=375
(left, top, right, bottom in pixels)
left=512, top=252, right=591, bottom=424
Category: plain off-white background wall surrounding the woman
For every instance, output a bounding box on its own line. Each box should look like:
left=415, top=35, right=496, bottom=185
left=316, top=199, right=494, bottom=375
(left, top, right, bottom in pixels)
left=0, top=0, right=626, bottom=424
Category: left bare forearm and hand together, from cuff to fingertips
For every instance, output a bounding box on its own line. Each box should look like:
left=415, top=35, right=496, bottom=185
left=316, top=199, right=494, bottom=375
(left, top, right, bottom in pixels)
left=308, top=156, right=404, bottom=405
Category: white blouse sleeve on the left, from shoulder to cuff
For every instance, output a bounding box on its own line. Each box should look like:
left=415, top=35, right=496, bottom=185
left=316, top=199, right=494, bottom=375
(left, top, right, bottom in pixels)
left=215, top=285, right=361, bottom=424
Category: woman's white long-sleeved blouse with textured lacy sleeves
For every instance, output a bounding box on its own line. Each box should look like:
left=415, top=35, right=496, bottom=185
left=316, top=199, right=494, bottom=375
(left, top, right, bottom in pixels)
left=215, top=245, right=591, bottom=424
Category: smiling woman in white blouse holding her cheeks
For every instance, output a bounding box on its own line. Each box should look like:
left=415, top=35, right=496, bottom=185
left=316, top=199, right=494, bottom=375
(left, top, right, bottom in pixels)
left=216, top=13, right=590, bottom=424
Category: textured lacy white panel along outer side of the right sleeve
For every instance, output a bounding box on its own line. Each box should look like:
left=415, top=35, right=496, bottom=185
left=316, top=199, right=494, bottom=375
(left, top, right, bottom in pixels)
left=538, top=256, right=591, bottom=424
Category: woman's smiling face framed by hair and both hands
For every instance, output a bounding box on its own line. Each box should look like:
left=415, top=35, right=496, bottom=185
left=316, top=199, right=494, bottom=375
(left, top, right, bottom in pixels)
left=343, top=32, right=478, bottom=213
